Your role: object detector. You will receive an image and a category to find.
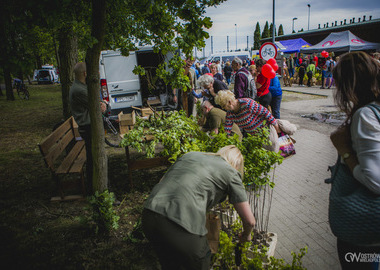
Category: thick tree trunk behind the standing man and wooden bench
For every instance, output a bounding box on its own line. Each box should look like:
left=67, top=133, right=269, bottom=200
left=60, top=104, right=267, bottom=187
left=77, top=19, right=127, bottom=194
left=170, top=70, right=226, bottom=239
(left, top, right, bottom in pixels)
left=58, top=24, right=78, bottom=119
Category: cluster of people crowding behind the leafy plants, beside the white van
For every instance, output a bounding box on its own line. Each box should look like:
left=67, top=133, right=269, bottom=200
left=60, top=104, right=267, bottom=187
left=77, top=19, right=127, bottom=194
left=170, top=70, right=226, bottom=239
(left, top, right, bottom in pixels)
left=174, top=57, right=282, bottom=141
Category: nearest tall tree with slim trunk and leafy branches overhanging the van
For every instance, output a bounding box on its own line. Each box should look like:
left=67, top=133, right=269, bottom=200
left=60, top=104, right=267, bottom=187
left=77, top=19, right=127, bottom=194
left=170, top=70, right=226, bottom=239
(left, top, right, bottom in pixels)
left=86, top=0, right=224, bottom=191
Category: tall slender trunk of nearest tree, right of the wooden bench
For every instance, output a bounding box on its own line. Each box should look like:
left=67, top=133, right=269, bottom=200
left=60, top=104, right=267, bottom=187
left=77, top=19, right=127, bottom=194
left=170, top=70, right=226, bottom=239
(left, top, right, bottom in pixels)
left=86, top=0, right=108, bottom=192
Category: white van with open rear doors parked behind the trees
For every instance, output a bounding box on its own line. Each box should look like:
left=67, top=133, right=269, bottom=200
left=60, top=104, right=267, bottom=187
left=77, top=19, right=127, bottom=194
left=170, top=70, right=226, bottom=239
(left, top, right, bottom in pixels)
left=99, top=47, right=173, bottom=118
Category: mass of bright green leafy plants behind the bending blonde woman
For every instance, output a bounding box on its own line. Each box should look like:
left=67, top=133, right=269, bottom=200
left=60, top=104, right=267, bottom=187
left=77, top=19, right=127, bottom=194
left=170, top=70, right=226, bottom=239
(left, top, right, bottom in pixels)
left=121, top=111, right=283, bottom=189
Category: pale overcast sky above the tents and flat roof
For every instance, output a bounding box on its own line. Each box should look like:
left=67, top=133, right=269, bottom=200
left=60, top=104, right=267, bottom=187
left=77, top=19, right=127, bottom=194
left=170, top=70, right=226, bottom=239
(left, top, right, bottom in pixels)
left=198, top=0, right=380, bottom=56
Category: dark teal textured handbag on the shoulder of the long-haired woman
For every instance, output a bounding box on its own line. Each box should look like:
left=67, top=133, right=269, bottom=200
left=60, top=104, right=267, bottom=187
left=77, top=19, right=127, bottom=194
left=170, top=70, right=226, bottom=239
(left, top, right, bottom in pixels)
left=326, top=104, right=380, bottom=245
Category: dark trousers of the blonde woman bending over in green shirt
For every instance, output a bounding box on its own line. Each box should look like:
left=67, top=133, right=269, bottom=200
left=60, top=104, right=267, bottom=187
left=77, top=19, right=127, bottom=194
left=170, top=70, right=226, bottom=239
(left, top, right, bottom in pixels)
left=142, top=209, right=211, bottom=270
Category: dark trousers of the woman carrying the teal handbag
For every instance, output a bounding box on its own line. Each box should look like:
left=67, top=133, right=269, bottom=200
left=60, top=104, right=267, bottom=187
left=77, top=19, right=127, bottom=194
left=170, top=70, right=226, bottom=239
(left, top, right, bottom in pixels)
left=338, top=239, right=380, bottom=270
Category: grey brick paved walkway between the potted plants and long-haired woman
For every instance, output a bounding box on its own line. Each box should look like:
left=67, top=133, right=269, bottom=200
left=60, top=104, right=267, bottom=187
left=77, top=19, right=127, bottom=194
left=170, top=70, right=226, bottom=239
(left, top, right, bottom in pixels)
left=268, top=87, right=340, bottom=270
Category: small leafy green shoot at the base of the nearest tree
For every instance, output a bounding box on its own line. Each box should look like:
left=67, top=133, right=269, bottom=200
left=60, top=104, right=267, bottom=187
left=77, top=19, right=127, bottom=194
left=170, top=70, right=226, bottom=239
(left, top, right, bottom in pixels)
left=89, top=190, right=120, bottom=234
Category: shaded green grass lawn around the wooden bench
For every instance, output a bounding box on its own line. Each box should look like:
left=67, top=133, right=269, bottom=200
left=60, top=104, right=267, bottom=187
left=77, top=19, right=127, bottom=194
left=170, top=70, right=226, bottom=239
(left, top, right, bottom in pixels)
left=0, top=85, right=164, bottom=269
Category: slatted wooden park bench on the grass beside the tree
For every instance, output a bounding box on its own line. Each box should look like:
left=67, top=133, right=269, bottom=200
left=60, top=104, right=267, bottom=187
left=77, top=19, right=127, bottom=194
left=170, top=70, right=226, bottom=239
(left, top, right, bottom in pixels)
left=38, top=117, right=86, bottom=201
